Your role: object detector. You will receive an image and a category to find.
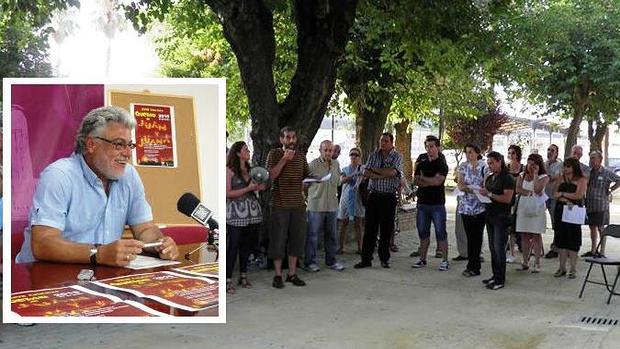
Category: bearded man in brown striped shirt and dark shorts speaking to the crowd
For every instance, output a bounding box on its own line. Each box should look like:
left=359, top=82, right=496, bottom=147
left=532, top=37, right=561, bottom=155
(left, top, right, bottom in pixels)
left=267, top=126, right=310, bottom=288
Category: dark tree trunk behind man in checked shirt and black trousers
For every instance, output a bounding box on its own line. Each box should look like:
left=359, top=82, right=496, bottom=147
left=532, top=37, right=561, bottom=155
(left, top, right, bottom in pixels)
left=353, top=97, right=392, bottom=163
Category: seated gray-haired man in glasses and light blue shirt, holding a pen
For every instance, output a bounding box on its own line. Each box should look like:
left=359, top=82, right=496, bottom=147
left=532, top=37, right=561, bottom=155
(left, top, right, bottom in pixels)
left=16, top=106, right=179, bottom=266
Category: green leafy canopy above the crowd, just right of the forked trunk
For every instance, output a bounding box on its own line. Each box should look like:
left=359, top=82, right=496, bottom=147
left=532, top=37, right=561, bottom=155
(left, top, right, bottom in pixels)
left=339, top=1, right=499, bottom=126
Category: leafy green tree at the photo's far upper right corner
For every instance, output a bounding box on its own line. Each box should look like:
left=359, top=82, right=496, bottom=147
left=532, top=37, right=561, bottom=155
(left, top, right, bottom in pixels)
left=497, top=0, right=620, bottom=154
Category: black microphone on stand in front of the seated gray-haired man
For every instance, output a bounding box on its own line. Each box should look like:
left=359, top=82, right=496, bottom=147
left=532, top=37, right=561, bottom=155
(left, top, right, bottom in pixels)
left=177, top=193, right=219, bottom=262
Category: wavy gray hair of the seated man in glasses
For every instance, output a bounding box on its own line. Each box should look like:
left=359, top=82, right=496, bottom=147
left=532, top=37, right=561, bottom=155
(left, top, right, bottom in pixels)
left=75, top=106, right=136, bottom=154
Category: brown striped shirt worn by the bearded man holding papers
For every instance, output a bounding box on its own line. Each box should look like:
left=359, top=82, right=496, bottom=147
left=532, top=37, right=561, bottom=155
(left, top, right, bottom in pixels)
left=267, top=148, right=310, bottom=209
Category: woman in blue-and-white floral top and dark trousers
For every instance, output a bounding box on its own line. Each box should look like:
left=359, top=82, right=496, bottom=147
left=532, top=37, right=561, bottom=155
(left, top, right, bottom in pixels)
left=456, top=144, right=487, bottom=277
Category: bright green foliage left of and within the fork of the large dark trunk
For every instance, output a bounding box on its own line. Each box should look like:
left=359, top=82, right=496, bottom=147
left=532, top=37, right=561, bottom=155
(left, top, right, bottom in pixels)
left=139, top=0, right=297, bottom=139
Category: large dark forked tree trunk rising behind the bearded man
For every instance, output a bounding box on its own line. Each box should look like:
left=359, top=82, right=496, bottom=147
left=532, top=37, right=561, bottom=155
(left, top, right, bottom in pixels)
left=127, top=0, right=357, bottom=163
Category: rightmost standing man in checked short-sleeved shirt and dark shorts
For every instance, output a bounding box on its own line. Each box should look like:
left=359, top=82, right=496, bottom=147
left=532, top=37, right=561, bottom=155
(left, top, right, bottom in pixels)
left=581, top=150, right=620, bottom=257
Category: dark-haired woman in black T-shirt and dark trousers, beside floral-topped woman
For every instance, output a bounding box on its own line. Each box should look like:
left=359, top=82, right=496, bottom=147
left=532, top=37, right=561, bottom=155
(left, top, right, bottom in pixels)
left=480, top=151, right=515, bottom=290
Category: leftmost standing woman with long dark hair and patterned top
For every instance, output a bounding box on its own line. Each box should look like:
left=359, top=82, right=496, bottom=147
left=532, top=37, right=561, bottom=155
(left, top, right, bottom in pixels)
left=226, top=141, right=266, bottom=294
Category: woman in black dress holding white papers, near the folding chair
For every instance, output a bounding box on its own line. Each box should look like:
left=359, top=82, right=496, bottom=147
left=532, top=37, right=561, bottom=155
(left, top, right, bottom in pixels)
left=553, top=158, right=588, bottom=279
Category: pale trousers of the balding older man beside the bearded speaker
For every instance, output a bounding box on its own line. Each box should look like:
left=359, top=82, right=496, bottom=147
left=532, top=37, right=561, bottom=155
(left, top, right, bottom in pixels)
left=304, top=211, right=338, bottom=266
